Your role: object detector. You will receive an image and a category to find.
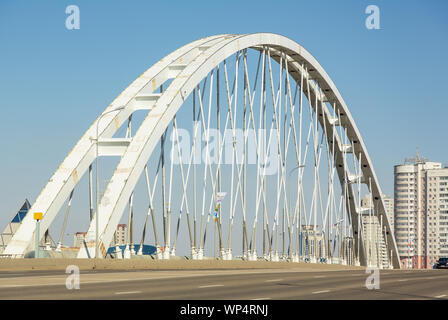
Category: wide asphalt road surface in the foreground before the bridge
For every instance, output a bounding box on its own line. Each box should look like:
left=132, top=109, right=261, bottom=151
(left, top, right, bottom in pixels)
left=0, top=269, right=448, bottom=300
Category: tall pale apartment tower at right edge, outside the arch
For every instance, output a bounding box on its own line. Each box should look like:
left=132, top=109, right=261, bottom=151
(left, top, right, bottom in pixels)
left=394, top=154, right=448, bottom=269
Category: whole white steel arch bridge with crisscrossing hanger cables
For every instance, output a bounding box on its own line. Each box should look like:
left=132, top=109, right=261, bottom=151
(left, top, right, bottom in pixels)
left=3, top=33, right=400, bottom=268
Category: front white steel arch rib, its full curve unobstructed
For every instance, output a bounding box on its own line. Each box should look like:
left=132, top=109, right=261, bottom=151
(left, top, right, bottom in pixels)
left=79, top=33, right=399, bottom=267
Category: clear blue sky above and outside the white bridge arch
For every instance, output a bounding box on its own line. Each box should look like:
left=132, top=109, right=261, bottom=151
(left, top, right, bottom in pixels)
left=0, top=0, right=448, bottom=246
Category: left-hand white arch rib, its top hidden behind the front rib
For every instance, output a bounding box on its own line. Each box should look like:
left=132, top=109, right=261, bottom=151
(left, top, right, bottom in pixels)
left=3, top=35, right=233, bottom=257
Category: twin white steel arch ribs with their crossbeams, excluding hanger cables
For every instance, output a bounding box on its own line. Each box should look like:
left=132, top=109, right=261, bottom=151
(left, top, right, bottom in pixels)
left=5, top=33, right=400, bottom=268
